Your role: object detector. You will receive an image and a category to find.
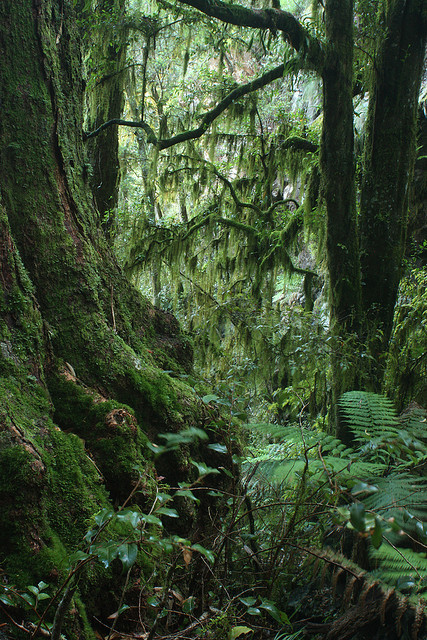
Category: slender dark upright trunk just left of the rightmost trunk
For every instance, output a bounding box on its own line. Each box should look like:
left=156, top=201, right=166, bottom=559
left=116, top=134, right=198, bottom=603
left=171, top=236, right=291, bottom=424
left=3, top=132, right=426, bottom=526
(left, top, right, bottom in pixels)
left=320, top=0, right=361, bottom=435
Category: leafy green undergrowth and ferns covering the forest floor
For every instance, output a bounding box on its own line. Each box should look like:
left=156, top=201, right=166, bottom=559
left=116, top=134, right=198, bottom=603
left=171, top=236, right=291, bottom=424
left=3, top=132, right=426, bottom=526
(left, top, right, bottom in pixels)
left=0, top=392, right=427, bottom=640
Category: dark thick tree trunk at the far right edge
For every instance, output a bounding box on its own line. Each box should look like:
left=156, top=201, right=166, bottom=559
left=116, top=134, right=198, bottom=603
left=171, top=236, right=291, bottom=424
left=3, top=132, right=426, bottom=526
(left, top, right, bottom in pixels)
left=360, top=0, right=427, bottom=391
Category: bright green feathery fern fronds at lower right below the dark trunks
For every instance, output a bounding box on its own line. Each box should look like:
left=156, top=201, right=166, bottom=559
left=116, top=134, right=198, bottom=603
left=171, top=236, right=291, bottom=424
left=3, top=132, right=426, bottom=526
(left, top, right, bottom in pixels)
left=244, top=391, right=427, bottom=592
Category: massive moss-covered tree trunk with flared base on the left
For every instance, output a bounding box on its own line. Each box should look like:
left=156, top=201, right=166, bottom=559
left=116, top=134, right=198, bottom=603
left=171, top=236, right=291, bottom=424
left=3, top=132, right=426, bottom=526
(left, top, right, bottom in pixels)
left=0, top=0, right=221, bottom=638
